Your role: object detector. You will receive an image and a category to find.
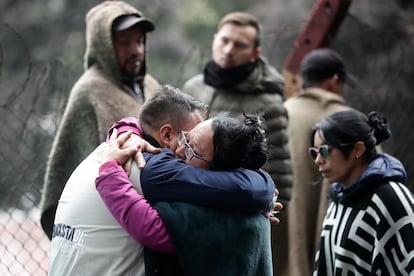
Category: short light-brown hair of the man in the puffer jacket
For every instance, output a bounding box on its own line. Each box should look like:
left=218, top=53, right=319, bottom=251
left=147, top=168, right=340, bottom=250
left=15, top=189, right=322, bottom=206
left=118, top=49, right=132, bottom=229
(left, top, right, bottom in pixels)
left=217, top=12, right=262, bottom=48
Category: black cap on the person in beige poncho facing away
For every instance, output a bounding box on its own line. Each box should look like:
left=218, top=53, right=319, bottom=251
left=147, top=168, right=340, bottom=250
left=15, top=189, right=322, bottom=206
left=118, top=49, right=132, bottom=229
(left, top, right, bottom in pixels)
left=301, top=48, right=357, bottom=88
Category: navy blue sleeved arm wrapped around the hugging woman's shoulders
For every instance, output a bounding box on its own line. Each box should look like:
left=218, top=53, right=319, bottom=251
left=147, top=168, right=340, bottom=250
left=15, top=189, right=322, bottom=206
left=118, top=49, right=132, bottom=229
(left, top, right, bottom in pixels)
left=141, top=149, right=275, bottom=212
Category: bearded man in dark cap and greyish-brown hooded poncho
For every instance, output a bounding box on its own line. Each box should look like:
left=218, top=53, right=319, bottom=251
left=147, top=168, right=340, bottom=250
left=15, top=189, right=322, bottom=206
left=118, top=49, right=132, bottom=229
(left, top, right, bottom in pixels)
left=41, top=1, right=159, bottom=238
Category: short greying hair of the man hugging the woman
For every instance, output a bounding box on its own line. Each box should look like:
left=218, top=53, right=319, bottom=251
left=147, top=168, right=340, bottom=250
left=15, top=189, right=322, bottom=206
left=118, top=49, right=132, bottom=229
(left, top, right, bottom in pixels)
left=139, top=85, right=209, bottom=131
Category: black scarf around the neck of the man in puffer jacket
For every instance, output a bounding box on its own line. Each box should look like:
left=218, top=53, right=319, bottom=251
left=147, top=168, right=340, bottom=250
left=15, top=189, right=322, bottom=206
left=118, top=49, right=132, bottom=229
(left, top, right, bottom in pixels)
left=204, top=60, right=257, bottom=88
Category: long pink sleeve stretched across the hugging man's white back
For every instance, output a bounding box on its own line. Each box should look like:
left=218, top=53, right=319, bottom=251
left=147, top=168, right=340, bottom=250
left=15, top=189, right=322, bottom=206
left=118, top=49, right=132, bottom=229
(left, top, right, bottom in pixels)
left=95, top=160, right=175, bottom=254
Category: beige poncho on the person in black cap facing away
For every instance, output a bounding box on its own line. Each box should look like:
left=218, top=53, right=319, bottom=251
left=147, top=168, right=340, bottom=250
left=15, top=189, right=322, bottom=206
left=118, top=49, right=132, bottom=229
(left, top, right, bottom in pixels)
left=279, top=87, right=350, bottom=276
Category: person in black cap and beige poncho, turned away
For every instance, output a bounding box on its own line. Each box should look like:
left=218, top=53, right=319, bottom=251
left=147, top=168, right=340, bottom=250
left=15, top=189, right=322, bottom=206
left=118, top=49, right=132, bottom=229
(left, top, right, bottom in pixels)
left=284, top=49, right=355, bottom=276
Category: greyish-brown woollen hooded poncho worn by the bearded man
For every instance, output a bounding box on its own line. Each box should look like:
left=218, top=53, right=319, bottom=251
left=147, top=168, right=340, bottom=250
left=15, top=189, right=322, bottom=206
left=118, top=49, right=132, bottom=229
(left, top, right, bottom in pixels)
left=41, top=1, right=159, bottom=238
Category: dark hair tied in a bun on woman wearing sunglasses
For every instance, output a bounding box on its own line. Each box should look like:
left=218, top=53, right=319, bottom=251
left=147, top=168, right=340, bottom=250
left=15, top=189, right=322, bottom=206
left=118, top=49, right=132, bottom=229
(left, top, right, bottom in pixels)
left=310, top=110, right=391, bottom=162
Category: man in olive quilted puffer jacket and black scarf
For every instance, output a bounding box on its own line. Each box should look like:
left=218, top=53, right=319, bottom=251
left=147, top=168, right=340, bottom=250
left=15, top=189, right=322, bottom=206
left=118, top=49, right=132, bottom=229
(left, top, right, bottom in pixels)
left=183, top=12, right=292, bottom=270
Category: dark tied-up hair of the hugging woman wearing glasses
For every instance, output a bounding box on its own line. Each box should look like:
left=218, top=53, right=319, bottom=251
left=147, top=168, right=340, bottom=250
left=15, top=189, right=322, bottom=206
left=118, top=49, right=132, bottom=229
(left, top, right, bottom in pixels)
left=212, top=113, right=269, bottom=171
